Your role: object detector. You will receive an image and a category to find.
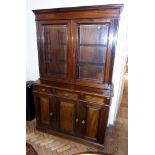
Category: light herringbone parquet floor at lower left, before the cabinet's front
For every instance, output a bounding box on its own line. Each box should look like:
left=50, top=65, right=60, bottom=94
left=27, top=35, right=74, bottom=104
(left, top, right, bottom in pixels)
left=26, top=121, right=96, bottom=155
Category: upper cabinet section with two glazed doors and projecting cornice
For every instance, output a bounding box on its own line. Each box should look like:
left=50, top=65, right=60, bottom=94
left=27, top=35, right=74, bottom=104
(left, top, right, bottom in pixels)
left=33, top=5, right=123, bottom=88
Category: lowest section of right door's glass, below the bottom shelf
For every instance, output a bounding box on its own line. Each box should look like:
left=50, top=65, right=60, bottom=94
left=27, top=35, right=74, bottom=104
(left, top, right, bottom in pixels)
left=79, top=65, right=104, bottom=82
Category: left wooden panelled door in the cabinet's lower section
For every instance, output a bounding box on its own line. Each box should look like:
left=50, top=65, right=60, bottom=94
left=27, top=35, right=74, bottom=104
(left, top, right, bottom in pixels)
left=34, top=93, right=56, bottom=128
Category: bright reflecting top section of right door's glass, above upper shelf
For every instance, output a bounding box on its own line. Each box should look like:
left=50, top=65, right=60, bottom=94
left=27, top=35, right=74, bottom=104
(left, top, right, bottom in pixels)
left=80, top=24, right=108, bottom=45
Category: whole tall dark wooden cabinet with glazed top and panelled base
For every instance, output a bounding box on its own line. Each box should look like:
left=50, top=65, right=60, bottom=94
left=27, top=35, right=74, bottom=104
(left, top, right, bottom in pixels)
left=33, top=4, right=123, bottom=148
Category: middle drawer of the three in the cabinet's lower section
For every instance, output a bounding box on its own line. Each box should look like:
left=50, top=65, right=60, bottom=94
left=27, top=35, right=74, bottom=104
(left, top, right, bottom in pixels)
left=55, top=90, right=78, bottom=100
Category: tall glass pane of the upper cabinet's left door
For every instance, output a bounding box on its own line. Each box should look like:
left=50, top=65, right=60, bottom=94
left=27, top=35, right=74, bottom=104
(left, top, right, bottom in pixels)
left=44, top=25, right=68, bottom=77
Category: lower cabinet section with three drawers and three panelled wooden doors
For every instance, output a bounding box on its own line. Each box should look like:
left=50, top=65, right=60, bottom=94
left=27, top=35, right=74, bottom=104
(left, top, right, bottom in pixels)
left=33, top=84, right=110, bottom=149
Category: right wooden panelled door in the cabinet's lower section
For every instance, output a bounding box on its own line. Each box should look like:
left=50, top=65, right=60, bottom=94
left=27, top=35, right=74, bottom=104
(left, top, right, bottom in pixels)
left=76, top=101, right=109, bottom=144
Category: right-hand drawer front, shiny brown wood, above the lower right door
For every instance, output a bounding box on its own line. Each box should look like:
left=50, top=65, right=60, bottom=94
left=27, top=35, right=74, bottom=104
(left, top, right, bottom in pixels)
left=80, top=95, right=105, bottom=103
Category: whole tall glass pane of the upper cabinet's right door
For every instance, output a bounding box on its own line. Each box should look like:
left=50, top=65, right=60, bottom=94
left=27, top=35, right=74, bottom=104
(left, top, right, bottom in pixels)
left=77, top=24, right=109, bottom=82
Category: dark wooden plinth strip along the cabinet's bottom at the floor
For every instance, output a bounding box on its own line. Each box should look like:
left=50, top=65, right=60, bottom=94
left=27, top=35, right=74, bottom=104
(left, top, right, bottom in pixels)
left=36, top=126, right=104, bottom=150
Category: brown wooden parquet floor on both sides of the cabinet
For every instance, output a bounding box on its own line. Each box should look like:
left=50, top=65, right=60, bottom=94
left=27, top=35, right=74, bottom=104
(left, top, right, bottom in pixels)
left=26, top=80, right=128, bottom=155
